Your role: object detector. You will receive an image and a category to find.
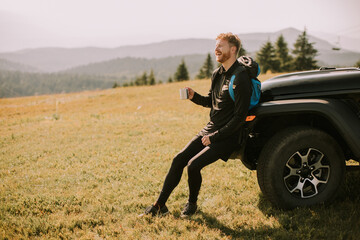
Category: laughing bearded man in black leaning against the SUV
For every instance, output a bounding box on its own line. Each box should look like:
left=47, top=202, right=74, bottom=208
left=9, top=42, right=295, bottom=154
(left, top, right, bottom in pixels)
left=143, top=33, right=251, bottom=217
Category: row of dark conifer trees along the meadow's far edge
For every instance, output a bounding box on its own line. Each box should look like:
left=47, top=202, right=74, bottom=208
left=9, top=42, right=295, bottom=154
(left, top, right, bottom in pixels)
left=114, top=30, right=319, bottom=87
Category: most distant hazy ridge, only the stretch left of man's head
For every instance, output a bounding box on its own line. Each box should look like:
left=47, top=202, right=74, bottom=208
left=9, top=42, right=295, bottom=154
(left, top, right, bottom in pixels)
left=0, top=39, right=215, bottom=72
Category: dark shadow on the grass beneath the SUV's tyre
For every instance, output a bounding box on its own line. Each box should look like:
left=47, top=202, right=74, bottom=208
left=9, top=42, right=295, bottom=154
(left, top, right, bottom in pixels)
left=258, top=171, right=360, bottom=239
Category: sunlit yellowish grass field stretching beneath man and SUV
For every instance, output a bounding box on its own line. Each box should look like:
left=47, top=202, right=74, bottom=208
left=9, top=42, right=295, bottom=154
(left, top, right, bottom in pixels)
left=0, top=75, right=360, bottom=239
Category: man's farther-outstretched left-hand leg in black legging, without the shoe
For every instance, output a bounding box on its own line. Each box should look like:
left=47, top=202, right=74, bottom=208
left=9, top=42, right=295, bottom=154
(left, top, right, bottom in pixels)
left=156, top=136, right=205, bottom=207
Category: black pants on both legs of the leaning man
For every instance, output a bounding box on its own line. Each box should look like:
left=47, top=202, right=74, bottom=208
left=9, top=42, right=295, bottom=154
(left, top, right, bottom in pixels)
left=157, top=134, right=238, bottom=205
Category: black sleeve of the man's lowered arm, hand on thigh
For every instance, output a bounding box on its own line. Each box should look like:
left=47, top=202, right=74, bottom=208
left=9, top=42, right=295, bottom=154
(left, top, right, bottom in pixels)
left=210, top=71, right=252, bottom=143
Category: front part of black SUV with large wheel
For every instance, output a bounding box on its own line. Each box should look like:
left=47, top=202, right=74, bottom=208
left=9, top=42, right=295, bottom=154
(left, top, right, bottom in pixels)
left=232, top=68, right=360, bottom=209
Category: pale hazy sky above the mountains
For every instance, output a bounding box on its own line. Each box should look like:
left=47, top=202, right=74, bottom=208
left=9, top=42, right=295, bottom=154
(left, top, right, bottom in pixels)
left=0, top=0, right=360, bottom=50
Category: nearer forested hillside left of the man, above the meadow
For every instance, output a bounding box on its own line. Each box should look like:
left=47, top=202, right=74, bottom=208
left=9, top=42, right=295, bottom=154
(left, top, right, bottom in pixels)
left=0, top=55, right=216, bottom=98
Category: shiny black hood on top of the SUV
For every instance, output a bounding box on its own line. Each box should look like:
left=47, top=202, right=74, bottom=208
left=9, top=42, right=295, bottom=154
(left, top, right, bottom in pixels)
left=261, top=68, right=360, bottom=101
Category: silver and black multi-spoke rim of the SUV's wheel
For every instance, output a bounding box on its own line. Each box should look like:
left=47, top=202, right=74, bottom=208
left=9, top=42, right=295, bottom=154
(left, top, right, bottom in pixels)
left=283, top=148, right=330, bottom=198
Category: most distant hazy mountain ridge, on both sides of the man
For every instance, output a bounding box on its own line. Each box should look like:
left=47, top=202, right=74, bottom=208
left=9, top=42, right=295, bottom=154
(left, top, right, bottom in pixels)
left=0, top=28, right=360, bottom=72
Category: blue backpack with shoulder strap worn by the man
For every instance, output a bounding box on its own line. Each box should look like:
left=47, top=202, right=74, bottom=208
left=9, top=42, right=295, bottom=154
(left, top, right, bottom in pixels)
left=229, top=56, right=261, bottom=110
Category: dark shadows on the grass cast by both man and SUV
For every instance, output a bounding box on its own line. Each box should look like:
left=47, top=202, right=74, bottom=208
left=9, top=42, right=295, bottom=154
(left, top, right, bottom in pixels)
left=192, top=171, right=360, bottom=239
